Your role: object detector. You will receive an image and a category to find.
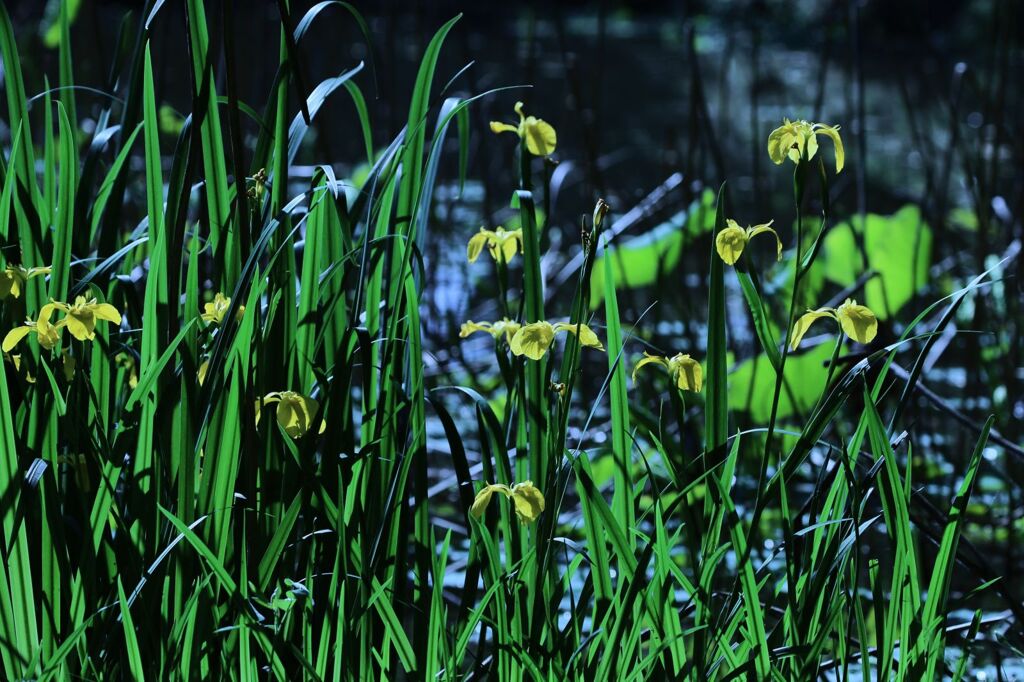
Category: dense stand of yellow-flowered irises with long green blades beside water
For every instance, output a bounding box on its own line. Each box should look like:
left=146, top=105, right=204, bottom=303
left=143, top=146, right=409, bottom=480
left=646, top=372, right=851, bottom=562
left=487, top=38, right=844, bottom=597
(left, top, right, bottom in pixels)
left=0, top=0, right=1007, bottom=681
